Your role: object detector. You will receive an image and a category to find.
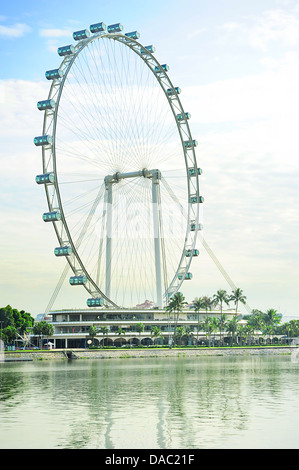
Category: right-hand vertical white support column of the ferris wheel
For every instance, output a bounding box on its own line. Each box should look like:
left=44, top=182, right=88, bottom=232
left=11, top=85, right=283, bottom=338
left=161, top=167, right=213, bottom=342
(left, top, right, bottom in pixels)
left=152, top=177, right=162, bottom=308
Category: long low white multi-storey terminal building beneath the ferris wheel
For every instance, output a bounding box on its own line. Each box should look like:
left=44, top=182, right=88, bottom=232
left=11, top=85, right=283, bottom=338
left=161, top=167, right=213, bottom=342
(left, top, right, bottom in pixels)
left=44, top=301, right=240, bottom=349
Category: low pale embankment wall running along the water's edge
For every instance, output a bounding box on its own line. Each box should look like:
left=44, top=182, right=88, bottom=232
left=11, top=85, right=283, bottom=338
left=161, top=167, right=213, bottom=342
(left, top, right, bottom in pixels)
left=5, top=346, right=297, bottom=361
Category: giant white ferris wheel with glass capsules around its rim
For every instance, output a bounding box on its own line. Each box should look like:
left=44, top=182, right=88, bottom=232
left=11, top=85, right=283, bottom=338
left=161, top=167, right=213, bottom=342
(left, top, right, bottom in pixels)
left=34, top=23, right=203, bottom=308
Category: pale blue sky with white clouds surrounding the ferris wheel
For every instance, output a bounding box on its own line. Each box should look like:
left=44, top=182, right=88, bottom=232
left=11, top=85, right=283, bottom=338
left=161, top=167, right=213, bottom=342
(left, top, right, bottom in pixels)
left=0, top=0, right=299, bottom=319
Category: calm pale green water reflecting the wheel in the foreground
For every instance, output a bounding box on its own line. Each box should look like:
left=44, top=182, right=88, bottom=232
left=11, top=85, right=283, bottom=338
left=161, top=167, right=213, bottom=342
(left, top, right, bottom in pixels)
left=0, top=356, right=299, bottom=449
